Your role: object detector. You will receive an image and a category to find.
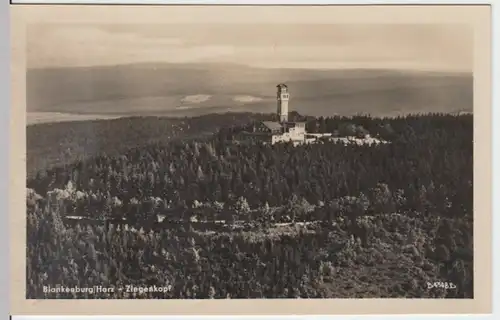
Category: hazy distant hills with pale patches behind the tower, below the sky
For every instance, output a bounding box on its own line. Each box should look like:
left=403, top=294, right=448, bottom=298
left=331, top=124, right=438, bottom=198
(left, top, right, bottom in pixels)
left=27, top=64, right=473, bottom=116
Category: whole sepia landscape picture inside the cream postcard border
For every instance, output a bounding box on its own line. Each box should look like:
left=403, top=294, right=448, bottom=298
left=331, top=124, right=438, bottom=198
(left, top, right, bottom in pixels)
left=25, top=4, right=480, bottom=299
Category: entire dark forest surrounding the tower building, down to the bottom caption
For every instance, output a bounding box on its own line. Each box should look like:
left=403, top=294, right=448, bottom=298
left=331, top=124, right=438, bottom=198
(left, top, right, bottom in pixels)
left=27, top=114, right=473, bottom=299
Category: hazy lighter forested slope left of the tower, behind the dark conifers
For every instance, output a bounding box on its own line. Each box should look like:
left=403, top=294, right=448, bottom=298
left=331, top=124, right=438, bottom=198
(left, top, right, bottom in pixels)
left=26, top=113, right=271, bottom=175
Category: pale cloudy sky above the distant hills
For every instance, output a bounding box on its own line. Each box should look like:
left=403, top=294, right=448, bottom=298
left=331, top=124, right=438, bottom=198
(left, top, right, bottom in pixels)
left=26, top=24, right=474, bottom=72
